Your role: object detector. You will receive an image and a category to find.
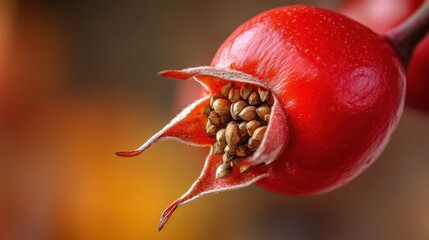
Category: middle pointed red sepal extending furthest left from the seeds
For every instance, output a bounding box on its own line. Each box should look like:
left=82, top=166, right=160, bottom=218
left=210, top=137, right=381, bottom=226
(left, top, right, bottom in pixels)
left=116, top=97, right=214, bottom=157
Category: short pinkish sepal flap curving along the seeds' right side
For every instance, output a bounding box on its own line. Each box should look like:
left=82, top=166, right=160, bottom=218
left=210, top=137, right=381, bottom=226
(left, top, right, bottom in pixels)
left=239, top=101, right=289, bottom=171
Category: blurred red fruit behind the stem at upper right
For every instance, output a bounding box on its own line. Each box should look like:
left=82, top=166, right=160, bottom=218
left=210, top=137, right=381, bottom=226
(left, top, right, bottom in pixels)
left=341, top=0, right=429, bottom=112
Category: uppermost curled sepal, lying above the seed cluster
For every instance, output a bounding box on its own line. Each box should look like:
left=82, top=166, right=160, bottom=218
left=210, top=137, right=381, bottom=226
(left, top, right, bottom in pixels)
left=159, top=66, right=266, bottom=93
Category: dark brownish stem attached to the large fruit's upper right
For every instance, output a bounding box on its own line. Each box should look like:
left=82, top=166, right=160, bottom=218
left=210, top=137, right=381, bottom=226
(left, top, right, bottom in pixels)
left=384, top=0, right=429, bottom=68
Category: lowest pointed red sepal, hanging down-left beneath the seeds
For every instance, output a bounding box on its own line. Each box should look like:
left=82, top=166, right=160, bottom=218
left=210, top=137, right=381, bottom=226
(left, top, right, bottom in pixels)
left=158, top=154, right=268, bottom=230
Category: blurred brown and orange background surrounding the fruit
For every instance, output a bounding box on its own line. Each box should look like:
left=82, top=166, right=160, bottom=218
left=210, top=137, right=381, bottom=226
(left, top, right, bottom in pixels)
left=0, top=0, right=429, bottom=240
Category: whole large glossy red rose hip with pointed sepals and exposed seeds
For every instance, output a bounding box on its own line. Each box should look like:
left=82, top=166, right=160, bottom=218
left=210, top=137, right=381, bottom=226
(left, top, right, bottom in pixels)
left=117, top=6, right=405, bottom=228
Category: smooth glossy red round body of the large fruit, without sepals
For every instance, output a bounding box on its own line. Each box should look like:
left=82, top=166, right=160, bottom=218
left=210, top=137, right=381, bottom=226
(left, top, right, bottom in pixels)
left=211, top=6, right=405, bottom=195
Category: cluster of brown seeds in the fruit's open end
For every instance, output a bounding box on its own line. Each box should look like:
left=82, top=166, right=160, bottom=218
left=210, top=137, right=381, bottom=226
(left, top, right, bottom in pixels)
left=204, top=83, right=273, bottom=178
